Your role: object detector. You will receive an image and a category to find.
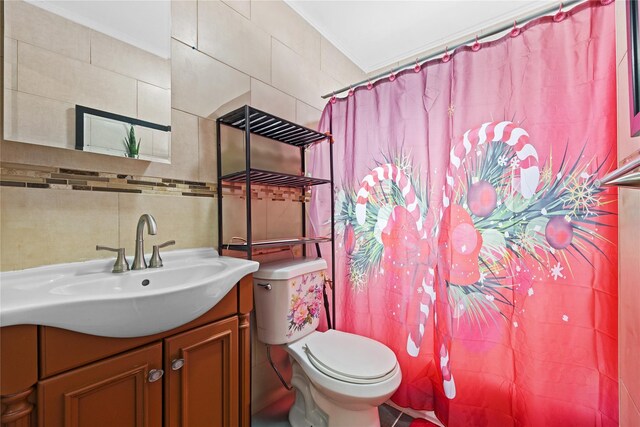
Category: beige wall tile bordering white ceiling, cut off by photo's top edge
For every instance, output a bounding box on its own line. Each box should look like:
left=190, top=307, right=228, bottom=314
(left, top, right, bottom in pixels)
left=251, top=1, right=322, bottom=67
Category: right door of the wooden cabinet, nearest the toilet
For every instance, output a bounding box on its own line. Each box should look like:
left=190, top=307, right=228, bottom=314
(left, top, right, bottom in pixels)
left=165, top=317, right=239, bottom=427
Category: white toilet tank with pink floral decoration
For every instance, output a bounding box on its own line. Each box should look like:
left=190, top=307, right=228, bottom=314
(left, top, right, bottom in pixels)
left=253, top=258, right=327, bottom=344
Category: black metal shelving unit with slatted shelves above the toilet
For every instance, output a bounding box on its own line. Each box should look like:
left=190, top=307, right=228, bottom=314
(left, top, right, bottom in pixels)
left=216, top=105, right=335, bottom=326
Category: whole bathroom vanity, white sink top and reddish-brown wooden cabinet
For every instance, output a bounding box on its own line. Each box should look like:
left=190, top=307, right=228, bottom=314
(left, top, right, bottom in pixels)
left=0, top=248, right=258, bottom=427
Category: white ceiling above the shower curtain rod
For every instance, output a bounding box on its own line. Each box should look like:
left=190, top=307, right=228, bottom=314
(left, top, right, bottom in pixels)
left=285, top=0, right=559, bottom=73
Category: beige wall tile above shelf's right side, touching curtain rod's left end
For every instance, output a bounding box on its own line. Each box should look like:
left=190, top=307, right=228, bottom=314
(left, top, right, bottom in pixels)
left=271, top=39, right=340, bottom=109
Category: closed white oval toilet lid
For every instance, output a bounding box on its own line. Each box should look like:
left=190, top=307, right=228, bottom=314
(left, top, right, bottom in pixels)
left=304, top=329, right=398, bottom=384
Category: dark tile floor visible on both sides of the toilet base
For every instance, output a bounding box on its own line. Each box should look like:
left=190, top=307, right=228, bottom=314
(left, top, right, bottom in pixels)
left=251, top=393, right=413, bottom=427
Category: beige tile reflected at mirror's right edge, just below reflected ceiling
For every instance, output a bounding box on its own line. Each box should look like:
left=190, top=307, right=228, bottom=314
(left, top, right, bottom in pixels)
left=91, top=31, right=171, bottom=89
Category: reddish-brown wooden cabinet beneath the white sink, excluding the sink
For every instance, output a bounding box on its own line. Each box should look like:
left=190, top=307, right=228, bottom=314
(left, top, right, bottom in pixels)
left=0, top=276, right=253, bottom=427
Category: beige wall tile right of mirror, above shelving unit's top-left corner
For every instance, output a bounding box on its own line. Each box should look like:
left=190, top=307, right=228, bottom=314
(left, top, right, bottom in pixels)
left=171, top=39, right=250, bottom=118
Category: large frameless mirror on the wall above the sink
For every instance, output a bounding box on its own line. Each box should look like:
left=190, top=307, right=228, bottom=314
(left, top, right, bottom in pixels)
left=3, top=0, right=171, bottom=163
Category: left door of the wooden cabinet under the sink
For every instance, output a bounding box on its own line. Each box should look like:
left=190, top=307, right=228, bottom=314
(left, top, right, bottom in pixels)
left=38, top=343, right=162, bottom=427
